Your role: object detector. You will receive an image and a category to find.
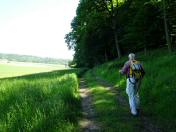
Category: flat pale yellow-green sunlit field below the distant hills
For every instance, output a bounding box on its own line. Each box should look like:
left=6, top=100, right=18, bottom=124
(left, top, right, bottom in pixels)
left=0, top=62, right=65, bottom=78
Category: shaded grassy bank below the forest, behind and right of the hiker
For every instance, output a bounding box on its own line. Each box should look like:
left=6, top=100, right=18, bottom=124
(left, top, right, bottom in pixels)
left=93, top=49, right=176, bottom=131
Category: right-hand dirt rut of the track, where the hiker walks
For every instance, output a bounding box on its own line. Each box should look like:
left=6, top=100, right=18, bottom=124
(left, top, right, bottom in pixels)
left=96, top=77, right=164, bottom=132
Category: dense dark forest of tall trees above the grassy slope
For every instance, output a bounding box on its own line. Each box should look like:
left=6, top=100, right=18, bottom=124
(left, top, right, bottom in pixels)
left=65, top=0, right=176, bottom=67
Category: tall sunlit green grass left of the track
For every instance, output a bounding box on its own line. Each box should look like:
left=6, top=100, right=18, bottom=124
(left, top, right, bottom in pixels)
left=0, top=71, right=80, bottom=132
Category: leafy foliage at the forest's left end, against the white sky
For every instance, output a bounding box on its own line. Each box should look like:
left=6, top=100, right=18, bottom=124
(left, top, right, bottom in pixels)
left=66, top=1, right=119, bottom=67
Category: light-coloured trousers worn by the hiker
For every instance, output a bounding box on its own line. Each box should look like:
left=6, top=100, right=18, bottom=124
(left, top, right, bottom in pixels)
left=126, top=78, right=141, bottom=115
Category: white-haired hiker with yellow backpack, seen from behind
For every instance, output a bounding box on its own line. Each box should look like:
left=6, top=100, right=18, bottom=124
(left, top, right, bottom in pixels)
left=119, top=53, right=145, bottom=116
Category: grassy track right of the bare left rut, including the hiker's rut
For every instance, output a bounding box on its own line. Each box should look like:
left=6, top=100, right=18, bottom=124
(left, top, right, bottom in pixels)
left=83, top=71, right=164, bottom=132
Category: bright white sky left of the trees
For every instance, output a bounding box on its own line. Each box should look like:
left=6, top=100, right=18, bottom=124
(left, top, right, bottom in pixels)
left=0, top=0, right=79, bottom=59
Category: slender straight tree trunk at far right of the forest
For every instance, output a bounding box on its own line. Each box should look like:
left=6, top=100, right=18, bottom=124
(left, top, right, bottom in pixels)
left=163, top=0, right=172, bottom=53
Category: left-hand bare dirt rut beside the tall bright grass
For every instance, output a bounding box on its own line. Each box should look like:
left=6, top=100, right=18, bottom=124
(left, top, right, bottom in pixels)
left=79, top=79, right=100, bottom=132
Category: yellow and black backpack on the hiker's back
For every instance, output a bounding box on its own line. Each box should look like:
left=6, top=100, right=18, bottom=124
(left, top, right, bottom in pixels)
left=129, top=60, right=145, bottom=81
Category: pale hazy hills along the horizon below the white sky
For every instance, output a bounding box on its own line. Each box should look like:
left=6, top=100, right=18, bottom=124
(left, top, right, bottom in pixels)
left=0, top=53, right=70, bottom=65
